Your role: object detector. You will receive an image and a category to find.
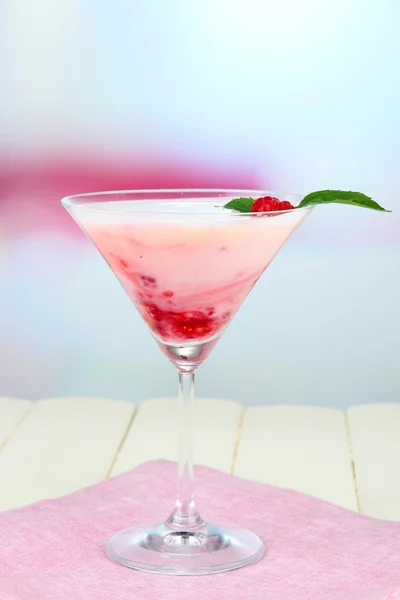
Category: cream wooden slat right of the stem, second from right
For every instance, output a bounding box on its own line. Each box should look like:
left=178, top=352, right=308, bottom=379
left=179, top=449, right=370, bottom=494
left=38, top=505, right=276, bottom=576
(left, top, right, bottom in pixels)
left=234, top=406, right=357, bottom=510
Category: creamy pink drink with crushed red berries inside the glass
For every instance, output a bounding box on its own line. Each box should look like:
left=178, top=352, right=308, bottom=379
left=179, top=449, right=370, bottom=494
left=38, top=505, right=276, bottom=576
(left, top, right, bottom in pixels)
left=80, top=201, right=305, bottom=345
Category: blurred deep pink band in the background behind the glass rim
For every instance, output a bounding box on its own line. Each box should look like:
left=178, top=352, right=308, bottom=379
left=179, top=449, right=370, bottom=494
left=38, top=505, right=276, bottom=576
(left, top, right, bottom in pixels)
left=0, top=157, right=257, bottom=235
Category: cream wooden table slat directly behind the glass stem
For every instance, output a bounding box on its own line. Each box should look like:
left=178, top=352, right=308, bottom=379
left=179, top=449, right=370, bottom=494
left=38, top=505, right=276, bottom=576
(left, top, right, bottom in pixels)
left=112, top=398, right=243, bottom=475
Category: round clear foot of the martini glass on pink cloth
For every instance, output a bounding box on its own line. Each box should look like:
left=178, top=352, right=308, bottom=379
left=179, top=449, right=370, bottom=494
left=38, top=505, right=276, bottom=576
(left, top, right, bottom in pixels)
left=107, top=523, right=264, bottom=575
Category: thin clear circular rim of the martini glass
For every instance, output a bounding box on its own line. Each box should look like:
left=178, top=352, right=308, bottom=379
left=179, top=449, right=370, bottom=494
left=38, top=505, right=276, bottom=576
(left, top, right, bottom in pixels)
left=61, top=188, right=313, bottom=217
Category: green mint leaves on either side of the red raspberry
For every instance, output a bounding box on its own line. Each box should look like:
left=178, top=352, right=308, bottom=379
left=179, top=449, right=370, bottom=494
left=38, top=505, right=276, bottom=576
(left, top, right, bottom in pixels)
left=224, top=190, right=392, bottom=213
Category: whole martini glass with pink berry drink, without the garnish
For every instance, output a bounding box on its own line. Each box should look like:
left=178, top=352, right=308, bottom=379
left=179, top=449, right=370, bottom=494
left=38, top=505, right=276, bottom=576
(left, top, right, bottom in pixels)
left=62, top=190, right=311, bottom=575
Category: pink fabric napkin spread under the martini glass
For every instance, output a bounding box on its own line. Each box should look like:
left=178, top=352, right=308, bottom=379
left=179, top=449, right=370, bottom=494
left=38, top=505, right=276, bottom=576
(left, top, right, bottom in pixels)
left=0, top=461, right=400, bottom=600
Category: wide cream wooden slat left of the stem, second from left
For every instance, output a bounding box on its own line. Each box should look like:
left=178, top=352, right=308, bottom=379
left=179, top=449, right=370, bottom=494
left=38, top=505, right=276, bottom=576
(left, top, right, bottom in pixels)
left=0, top=398, right=135, bottom=509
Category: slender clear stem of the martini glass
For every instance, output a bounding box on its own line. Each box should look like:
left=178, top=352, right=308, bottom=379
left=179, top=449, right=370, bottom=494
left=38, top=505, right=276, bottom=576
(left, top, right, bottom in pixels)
left=167, top=371, right=204, bottom=531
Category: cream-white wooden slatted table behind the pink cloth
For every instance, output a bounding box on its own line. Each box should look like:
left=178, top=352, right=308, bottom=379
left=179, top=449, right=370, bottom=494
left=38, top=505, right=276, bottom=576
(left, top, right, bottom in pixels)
left=0, top=398, right=400, bottom=521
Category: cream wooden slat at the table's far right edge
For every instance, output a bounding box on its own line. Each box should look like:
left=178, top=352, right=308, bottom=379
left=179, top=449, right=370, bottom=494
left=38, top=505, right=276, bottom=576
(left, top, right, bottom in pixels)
left=347, top=404, right=400, bottom=521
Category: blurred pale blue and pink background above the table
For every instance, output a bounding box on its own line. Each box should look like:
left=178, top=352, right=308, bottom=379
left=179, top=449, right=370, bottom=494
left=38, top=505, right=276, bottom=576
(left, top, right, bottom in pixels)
left=0, top=0, right=400, bottom=407
